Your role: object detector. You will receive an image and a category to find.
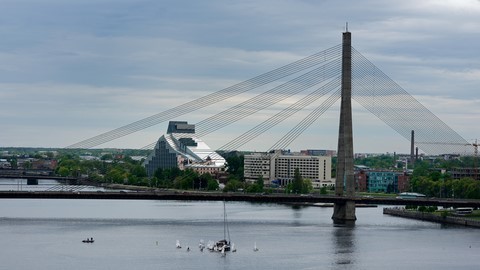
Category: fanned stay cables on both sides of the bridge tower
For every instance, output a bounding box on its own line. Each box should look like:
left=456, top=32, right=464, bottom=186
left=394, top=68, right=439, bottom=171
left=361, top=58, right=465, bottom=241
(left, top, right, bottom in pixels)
left=67, top=34, right=473, bottom=155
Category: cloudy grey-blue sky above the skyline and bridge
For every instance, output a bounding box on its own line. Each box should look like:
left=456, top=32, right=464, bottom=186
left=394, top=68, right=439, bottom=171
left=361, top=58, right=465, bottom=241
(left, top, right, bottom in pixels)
left=0, top=0, right=480, bottom=153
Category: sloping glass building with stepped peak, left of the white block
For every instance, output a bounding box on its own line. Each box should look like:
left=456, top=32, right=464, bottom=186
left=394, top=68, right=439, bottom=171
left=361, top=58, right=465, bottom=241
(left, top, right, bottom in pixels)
left=144, top=121, right=225, bottom=176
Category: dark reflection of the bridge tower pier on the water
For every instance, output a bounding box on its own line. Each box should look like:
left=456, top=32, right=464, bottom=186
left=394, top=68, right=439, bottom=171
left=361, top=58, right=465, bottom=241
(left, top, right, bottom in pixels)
left=333, top=224, right=355, bottom=269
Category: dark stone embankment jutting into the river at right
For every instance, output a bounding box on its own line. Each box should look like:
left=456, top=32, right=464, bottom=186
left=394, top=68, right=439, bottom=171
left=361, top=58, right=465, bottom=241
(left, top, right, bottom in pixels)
left=383, top=207, right=480, bottom=228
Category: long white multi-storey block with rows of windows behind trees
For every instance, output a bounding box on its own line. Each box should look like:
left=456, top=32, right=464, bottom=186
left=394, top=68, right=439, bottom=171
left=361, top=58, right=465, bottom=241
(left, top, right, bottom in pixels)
left=244, top=150, right=334, bottom=188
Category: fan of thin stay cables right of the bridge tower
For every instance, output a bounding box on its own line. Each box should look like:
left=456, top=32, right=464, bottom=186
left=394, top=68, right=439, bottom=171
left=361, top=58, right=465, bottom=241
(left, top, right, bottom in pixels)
left=352, top=49, right=467, bottom=154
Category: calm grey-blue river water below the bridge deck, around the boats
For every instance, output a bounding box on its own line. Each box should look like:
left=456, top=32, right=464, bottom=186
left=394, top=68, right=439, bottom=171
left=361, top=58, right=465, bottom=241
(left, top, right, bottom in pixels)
left=0, top=179, right=480, bottom=270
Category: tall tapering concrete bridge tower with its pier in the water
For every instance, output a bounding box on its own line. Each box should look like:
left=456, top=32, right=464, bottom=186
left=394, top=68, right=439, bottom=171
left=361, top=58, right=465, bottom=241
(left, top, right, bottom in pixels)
left=332, top=29, right=357, bottom=224
